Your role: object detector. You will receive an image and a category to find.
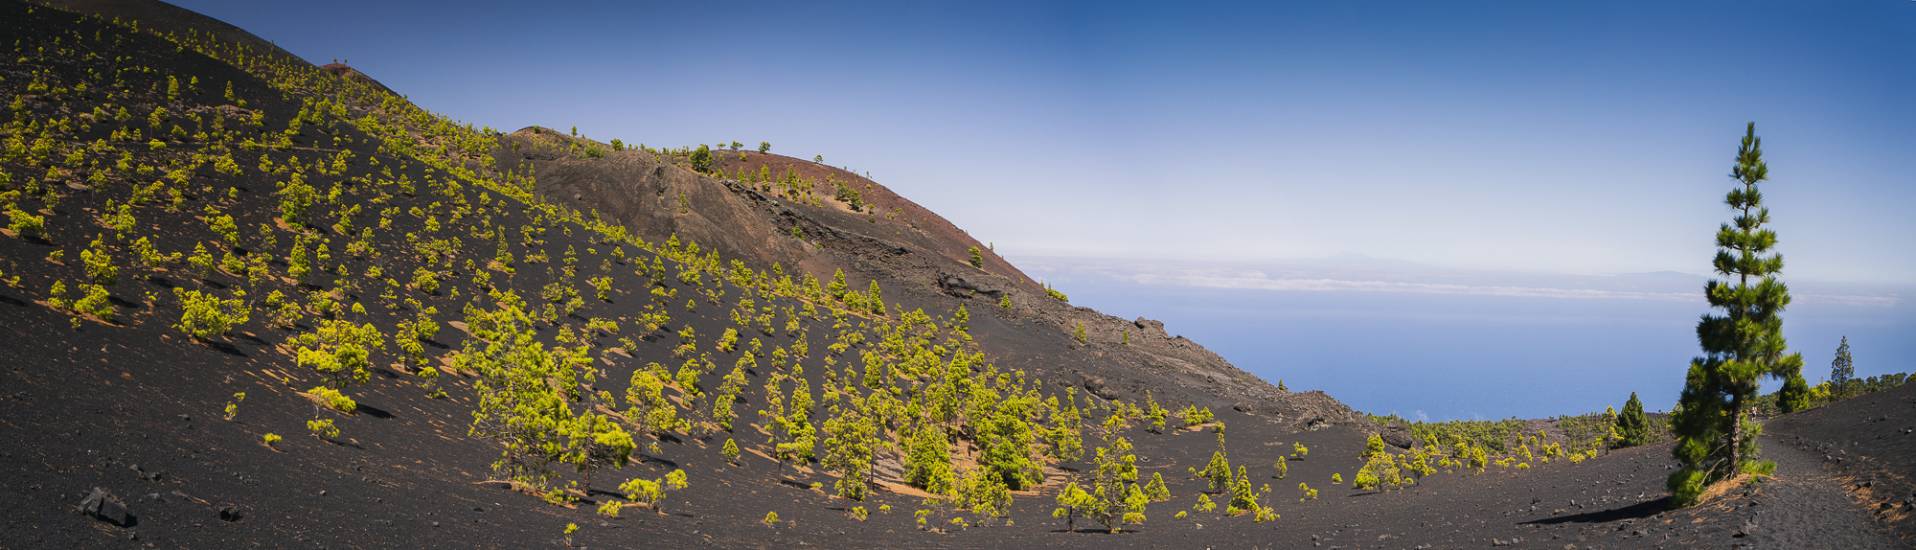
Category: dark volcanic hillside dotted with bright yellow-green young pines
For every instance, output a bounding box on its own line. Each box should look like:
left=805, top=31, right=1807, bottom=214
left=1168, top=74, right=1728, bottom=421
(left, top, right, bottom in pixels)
left=0, top=0, right=1908, bottom=548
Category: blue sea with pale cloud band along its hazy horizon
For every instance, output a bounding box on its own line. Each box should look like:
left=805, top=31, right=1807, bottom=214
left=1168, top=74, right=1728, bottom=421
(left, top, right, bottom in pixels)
left=1033, top=261, right=1916, bottom=420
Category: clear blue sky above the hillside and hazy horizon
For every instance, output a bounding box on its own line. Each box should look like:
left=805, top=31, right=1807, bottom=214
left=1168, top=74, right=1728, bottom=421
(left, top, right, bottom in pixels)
left=180, top=0, right=1916, bottom=284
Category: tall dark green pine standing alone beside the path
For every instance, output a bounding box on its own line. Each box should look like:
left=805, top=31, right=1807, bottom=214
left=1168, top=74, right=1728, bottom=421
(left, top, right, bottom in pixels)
left=1669, top=123, right=1807, bottom=506
